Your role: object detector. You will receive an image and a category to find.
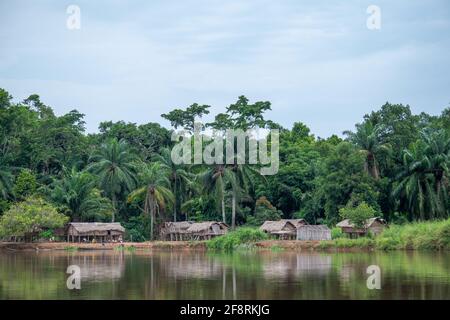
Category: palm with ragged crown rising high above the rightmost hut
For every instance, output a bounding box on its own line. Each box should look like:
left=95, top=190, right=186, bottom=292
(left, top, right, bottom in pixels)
left=344, top=121, right=390, bottom=180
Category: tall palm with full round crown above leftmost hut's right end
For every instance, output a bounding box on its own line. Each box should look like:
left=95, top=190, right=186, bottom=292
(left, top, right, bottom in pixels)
left=88, top=139, right=138, bottom=222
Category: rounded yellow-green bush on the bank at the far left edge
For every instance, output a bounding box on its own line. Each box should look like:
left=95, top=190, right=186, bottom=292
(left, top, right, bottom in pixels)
left=0, top=198, right=68, bottom=237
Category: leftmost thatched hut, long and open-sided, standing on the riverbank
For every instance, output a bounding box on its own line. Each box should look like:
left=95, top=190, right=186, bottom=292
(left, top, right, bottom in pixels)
left=67, top=222, right=125, bottom=242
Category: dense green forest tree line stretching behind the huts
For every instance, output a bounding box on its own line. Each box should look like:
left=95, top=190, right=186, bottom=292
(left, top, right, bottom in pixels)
left=0, top=89, right=450, bottom=241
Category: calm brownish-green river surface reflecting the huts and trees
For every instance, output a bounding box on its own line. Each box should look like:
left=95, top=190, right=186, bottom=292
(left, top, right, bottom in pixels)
left=0, top=251, right=450, bottom=299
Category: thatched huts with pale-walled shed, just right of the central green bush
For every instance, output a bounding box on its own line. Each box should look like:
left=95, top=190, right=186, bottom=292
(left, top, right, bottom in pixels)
left=260, top=219, right=331, bottom=240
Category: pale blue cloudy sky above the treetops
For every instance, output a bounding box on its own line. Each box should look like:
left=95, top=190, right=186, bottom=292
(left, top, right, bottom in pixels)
left=0, top=0, right=450, bottom=137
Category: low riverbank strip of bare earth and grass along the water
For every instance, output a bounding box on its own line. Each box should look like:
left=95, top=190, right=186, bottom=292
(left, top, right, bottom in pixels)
left=0, top=219, right=450, bottom=251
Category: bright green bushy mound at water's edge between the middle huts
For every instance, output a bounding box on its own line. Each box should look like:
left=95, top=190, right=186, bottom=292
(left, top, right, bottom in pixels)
left=207, top=227, right=268, bottom=251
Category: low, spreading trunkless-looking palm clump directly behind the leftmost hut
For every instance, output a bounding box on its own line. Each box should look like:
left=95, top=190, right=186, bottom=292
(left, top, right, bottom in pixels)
left=50, top=168, right=113, bottom=221
